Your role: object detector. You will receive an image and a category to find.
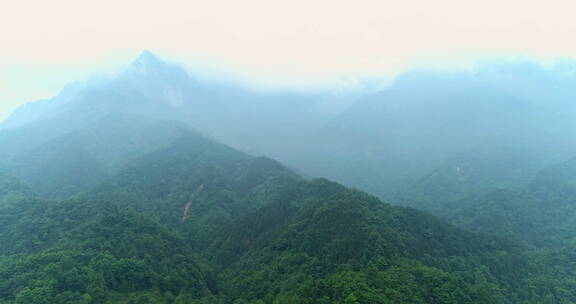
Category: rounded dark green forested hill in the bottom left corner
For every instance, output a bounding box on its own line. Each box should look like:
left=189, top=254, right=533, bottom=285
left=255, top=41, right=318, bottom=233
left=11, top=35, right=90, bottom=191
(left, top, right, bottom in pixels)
left=0, top=199, right=215, bottom=303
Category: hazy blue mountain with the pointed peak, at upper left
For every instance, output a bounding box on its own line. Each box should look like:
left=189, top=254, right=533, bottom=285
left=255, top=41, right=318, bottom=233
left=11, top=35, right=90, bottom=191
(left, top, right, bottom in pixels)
left=0, top=52, right=345, bottom=184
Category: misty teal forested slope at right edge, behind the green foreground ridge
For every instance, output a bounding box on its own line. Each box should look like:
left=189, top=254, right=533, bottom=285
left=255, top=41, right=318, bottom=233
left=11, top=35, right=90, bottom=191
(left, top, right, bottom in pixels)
left=400, top=159, right=576, bottom=248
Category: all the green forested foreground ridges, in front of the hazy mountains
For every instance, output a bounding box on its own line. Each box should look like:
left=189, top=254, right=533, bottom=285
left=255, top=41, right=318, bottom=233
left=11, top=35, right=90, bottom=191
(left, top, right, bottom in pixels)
left=0, top=124, right=576, bottom=304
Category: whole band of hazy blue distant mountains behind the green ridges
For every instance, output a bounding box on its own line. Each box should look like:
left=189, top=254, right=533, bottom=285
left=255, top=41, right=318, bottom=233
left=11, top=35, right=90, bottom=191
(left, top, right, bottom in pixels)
left=0, top=51, right=576, bottom=203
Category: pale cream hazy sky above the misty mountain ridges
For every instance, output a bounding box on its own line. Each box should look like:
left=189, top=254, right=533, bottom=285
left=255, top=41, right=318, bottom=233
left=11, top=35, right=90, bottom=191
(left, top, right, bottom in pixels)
left=0, top=0, right=576, bottom=119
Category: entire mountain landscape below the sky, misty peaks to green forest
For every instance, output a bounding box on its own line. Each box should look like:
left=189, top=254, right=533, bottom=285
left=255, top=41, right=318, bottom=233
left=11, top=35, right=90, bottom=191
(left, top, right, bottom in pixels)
left=0, top=52, right=576, bottom=304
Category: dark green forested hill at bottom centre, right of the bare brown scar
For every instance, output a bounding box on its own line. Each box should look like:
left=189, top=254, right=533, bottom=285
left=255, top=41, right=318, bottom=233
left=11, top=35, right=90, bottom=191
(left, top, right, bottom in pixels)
left=211, top=180, right=522, bottom=303
